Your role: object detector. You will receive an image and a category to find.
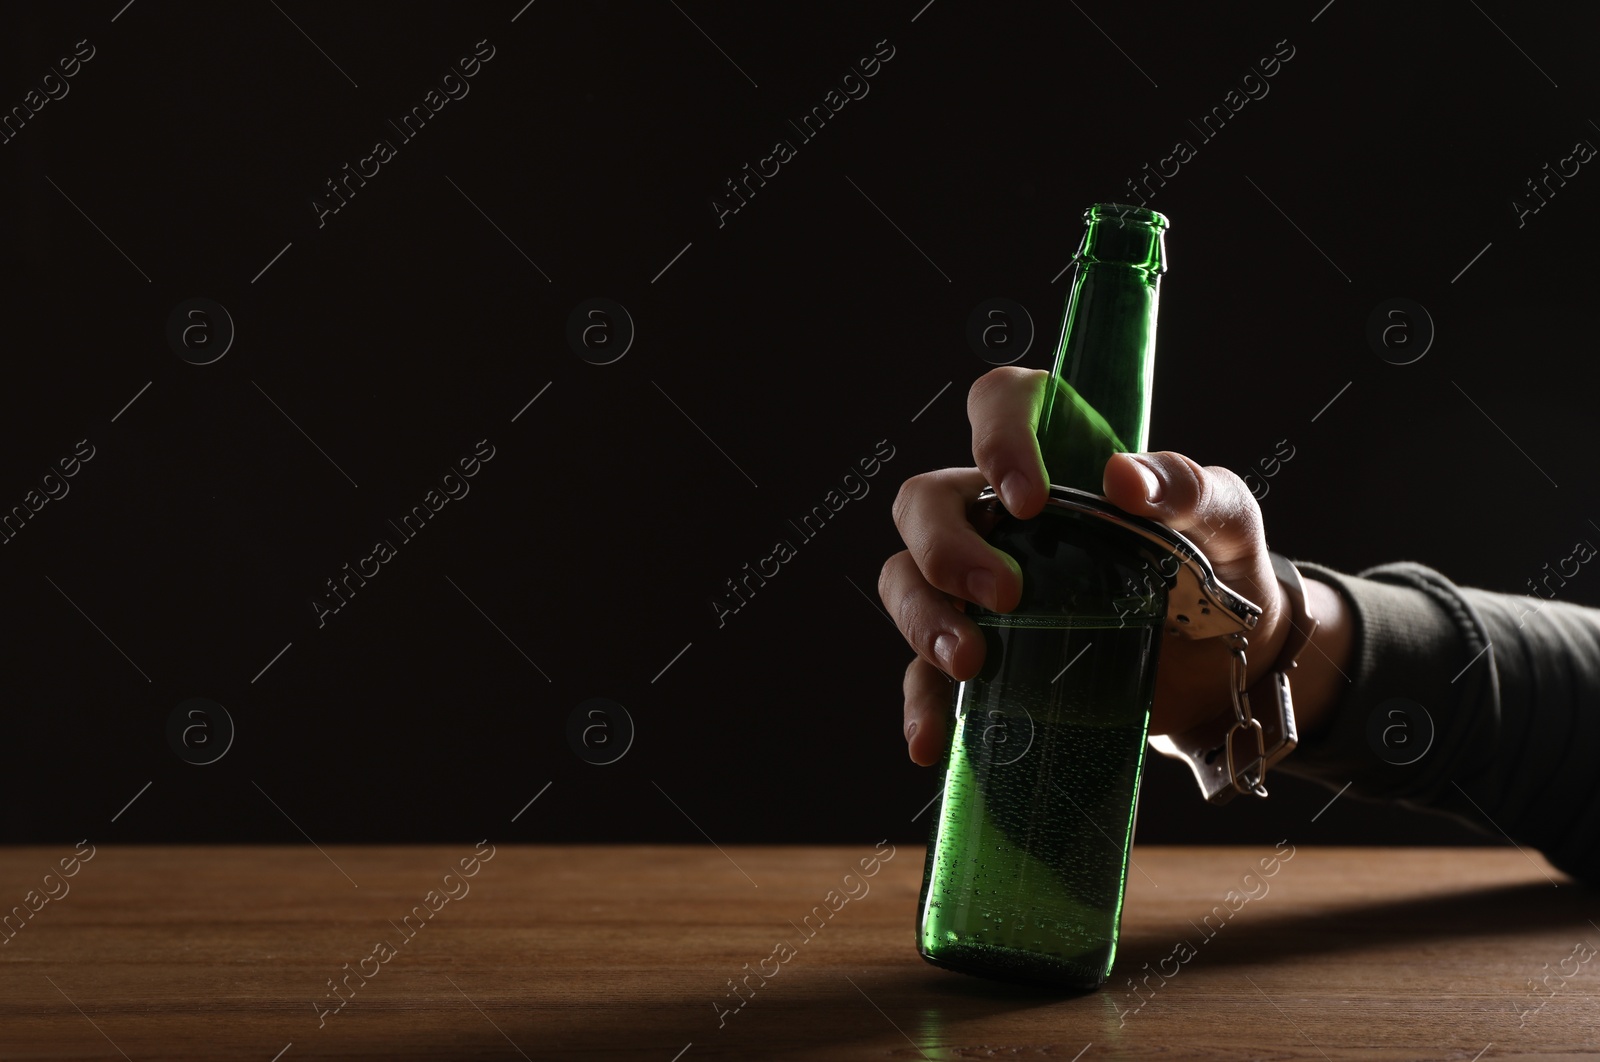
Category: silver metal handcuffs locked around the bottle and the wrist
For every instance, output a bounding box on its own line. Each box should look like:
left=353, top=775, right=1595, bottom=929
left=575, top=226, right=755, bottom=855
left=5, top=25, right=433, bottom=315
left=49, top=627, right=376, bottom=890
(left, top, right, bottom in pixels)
left=998, top=485, right=1317, bottom=804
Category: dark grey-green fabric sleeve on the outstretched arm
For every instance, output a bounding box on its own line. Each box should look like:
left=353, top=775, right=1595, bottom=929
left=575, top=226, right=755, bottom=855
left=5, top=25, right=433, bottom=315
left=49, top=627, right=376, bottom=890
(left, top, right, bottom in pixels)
left=1278, top=561, right=1600, bottom=883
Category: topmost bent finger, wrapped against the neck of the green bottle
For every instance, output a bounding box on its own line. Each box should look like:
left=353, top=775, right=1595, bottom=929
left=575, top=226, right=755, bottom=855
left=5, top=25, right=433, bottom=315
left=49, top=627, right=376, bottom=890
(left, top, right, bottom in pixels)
left=966, top=365, right=1050, bottom=520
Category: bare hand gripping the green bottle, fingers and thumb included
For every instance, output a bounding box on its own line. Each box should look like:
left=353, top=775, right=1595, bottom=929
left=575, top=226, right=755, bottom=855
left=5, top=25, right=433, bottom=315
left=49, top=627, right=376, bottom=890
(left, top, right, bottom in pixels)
left=878, top=366, right=1290, bottom=765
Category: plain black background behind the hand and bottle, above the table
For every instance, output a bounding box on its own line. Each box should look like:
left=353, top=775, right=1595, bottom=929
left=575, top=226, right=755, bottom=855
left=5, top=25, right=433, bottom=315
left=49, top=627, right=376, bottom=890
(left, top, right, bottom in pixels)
left=0, top=0, right=1600, bottom=843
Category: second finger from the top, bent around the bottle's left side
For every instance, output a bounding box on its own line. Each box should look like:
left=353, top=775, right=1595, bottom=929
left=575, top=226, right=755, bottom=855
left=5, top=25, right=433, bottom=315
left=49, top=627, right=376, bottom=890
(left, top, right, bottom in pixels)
left=878, top=469, right=1022, bottom=616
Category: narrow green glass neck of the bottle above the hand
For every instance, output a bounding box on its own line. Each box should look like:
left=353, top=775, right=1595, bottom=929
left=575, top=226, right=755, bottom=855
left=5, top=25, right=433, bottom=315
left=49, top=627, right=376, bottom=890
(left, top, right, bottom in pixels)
left=1038, top=235, right=1165, bottom=494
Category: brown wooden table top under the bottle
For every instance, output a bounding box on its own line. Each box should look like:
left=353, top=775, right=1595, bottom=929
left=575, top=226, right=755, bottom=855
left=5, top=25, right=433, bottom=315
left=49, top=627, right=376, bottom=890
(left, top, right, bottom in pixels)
left=0, top=844, right=1600, bottom=1062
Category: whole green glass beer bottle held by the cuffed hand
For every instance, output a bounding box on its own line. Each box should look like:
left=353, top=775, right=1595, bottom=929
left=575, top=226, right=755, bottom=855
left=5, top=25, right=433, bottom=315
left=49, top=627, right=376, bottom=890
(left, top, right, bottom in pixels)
left=917, top=203, right=1168, bottom=988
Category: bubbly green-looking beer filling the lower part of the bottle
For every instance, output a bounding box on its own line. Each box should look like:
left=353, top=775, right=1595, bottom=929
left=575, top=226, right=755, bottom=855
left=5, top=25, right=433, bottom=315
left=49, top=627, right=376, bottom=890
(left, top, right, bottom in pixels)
left=922, top=619, right=1157, bottom=985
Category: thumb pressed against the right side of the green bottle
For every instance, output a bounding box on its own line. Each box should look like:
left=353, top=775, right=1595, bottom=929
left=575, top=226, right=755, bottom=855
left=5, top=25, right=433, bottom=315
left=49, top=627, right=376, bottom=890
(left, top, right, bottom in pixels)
left=1104, top=451, right=1270, bottom=569
